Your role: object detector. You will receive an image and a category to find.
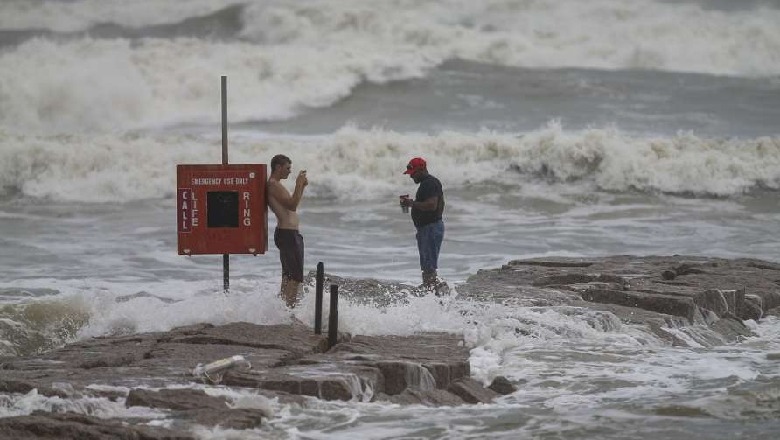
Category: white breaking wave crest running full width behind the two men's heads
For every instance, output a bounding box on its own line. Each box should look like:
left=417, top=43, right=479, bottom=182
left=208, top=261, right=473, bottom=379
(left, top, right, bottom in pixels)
left=0, top=123, right=780, bottom=202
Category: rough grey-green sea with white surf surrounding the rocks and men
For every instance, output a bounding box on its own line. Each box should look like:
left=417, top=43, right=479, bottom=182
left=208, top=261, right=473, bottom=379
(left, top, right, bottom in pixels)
left=0, top=0, right=780, bottom=439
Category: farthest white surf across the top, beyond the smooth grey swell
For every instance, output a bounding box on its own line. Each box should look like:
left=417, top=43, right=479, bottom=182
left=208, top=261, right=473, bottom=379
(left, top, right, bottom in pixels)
left=0, top=0, right=780, bottom=133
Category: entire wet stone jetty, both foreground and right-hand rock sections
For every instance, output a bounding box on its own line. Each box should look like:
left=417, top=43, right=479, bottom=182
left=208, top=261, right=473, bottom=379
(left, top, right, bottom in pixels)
left=0, top=256, right=780, bottom=439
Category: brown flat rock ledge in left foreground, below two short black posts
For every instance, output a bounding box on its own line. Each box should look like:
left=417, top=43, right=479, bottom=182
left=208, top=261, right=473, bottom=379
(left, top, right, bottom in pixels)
left=0, top=322, right=484, bottom=439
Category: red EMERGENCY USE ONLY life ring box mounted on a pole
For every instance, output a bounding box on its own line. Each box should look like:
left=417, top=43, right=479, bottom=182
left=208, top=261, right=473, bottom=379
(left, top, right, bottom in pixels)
left=176, top=164, right=268, bottom=255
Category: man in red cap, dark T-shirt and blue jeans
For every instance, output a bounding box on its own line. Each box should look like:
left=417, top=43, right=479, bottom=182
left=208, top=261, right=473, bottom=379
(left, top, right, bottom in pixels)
left=400, top=157, right=446, bottom=296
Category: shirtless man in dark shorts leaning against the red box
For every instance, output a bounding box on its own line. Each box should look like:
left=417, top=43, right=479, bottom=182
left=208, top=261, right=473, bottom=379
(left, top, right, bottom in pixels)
left=267, top=154, right=309, bottom=308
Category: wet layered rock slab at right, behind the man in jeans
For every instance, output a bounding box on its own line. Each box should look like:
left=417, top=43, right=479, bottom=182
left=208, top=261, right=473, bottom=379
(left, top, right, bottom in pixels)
left=457, top=255, right=780, bottom=345
